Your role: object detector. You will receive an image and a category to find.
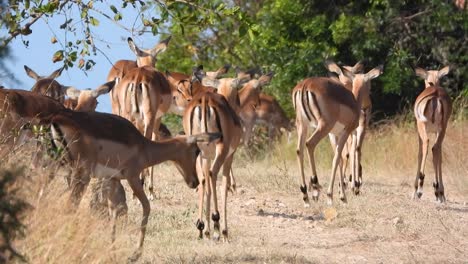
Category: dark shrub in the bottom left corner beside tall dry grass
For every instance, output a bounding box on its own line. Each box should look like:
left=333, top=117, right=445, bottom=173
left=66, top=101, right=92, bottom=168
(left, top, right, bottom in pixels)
left=0, top=169, right=28, bottom=263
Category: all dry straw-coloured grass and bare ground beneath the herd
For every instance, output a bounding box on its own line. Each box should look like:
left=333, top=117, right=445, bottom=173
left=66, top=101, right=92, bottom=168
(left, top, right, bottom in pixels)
left=4, top=121, right=468, bottom=263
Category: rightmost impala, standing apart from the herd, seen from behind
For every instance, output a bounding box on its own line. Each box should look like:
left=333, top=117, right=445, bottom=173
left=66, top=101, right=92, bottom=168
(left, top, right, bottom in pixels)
left=413, top=66, right=452, bottom=203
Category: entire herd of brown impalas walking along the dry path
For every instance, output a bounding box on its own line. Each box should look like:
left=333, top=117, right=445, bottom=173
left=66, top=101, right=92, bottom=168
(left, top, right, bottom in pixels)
left=0, top=37, right=451, bottom=257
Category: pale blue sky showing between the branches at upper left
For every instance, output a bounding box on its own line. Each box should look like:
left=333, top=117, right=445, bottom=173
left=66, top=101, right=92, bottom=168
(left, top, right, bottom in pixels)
left=0, top=1, right=168, bottom=112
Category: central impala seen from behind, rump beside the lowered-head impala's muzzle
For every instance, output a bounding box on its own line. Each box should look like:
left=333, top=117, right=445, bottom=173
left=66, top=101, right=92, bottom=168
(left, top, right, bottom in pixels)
left=183, top=92, right=242, bottom=240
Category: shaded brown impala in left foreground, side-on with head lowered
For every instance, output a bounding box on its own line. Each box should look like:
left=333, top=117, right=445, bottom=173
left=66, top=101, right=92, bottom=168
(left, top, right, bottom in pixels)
left=44, top=110, right=220, bottom=257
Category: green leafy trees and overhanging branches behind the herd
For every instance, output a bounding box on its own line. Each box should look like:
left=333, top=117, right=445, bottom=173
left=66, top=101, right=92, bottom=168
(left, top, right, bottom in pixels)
left=3, top=0, right=468, bottom=118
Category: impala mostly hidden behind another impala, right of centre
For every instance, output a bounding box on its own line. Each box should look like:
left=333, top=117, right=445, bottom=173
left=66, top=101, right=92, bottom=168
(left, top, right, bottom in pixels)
left=325, top=60, right=372, bottom=194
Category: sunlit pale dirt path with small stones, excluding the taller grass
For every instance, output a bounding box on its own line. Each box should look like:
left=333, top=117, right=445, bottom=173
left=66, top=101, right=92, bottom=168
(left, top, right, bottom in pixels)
left=120, top=163, right=468, bottom=263
